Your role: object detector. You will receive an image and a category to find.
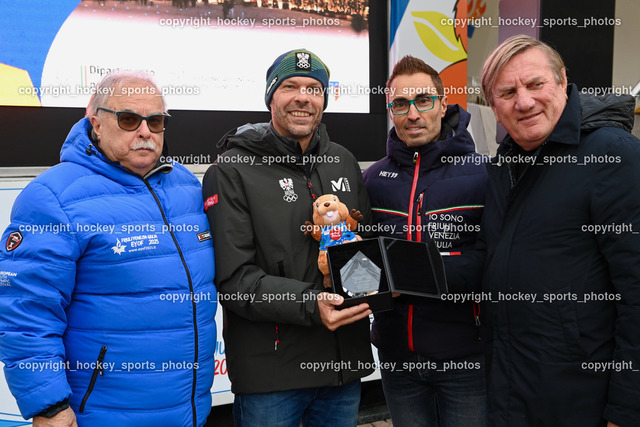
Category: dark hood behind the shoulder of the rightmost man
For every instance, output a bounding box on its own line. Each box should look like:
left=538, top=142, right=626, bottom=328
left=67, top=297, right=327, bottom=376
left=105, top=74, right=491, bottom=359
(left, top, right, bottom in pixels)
left=580, top=88, right=636, bottom=132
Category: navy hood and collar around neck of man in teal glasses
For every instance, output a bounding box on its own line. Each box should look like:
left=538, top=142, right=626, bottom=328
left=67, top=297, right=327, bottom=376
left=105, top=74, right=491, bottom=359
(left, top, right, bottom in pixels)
left=387, top=104, right=475, bottom=171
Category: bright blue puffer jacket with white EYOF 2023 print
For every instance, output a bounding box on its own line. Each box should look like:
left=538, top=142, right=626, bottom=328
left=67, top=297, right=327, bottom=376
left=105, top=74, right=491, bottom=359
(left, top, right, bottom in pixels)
left=0, top=119, right=217, bottom=426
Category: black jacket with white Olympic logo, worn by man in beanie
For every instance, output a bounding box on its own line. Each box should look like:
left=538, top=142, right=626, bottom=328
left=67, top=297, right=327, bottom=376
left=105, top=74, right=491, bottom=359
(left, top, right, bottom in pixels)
left=203, top=123, right=372, bottom=393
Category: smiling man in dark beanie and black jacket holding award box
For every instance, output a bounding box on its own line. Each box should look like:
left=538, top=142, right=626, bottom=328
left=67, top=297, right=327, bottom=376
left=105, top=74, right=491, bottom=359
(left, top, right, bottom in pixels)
left=203, top=49, right=373, bottom=427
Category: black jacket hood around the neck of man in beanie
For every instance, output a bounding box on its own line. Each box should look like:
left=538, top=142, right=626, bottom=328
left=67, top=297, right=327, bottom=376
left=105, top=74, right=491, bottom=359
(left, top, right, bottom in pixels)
left=216, top=123, right=329, bottom=157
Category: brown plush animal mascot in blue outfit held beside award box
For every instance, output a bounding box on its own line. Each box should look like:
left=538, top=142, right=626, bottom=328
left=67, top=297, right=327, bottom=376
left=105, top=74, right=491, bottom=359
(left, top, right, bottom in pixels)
left=305, top=194, right=362, bottom=280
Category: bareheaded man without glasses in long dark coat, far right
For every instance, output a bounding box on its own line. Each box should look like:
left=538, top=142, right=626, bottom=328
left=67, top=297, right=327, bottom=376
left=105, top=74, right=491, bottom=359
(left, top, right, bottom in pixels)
left=472, top=36, right=640, bottom=427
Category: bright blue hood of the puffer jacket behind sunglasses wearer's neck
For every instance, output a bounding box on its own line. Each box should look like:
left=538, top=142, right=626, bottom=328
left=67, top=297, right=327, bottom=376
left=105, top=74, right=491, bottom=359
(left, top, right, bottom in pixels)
left=60, top=117, right=173, bottom=184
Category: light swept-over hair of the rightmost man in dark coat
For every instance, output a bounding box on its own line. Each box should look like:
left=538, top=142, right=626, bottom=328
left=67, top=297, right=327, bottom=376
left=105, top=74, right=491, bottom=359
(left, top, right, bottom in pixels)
left=480, top=34, right=566, bottom=105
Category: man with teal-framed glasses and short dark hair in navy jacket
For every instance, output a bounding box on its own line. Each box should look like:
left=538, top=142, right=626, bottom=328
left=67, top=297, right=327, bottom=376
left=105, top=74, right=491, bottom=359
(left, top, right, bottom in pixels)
left=364, top=56, right=487, bottom=427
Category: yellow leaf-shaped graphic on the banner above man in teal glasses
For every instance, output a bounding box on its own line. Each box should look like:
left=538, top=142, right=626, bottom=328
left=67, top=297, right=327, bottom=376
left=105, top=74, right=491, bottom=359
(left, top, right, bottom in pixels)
left=411, top=12, right=467, bottom=63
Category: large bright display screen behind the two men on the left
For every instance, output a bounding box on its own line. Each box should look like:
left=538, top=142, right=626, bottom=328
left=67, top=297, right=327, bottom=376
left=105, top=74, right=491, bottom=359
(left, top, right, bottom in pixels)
left=0, top=0, right=372, bottom=113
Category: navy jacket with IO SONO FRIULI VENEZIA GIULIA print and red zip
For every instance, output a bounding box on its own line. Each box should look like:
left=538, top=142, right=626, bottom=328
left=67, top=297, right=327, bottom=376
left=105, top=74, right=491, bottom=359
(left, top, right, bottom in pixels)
left=364, top=105, right=487, bottom=361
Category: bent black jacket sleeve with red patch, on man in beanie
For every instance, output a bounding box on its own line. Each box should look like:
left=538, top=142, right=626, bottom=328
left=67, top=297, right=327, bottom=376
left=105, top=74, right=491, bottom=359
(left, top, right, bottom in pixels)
left=203, top=165, right=322, bottom=325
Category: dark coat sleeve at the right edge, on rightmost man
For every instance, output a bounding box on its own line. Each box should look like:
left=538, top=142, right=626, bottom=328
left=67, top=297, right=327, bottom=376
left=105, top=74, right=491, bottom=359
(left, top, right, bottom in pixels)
left=591, top=133, right=640, bottom=426
